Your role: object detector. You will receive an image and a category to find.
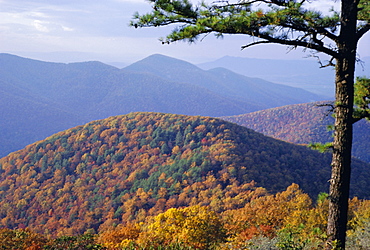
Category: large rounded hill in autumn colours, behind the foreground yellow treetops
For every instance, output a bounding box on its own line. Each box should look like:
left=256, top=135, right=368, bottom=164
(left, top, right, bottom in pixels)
left=0, top=113, right=370, bottom=235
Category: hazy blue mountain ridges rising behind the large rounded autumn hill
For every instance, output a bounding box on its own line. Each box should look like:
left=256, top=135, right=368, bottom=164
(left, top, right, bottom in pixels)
left=0, top=54, right=322, bottom=156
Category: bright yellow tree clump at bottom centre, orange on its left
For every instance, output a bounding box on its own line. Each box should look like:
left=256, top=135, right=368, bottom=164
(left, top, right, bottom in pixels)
left=99, top=206, right=227, bottom=249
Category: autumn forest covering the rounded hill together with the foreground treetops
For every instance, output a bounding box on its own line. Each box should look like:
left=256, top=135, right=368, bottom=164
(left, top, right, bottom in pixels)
left=0, top=112, right=370, bottom=249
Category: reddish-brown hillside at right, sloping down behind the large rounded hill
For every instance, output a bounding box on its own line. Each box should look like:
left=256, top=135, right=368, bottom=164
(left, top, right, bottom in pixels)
left=223, top=101, right=370, bottom=162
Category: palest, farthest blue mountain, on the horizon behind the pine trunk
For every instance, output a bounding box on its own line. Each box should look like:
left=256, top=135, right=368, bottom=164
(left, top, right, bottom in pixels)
left=198, top=56, right=370, bottom=96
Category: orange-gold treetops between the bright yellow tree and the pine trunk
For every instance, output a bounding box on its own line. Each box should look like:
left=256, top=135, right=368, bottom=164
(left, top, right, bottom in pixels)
left=223, top=184, right=318, bottom=241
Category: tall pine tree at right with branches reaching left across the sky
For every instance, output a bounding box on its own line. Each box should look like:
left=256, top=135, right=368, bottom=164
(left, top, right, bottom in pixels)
left=131, top=0, right=370, bottom=249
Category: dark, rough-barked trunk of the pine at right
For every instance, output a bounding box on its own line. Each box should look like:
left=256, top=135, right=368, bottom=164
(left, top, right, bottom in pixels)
left=327, top=0, right=357, bottom=249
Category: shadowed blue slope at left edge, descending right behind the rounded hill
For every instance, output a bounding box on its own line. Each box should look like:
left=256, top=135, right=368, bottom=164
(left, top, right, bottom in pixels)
left=0, top=78, right=84, bottom=157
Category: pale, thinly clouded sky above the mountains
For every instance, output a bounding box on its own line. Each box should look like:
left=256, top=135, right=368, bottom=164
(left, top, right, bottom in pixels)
left=0, top=0, right=370, bottom=64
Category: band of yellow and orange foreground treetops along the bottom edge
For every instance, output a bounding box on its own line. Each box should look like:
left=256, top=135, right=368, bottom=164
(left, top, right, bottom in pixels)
left=0, top=184, right=370, bottom=250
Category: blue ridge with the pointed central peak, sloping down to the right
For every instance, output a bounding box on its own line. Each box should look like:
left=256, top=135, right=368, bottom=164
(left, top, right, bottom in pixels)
left=125, top=55, right=324, bottom=109
